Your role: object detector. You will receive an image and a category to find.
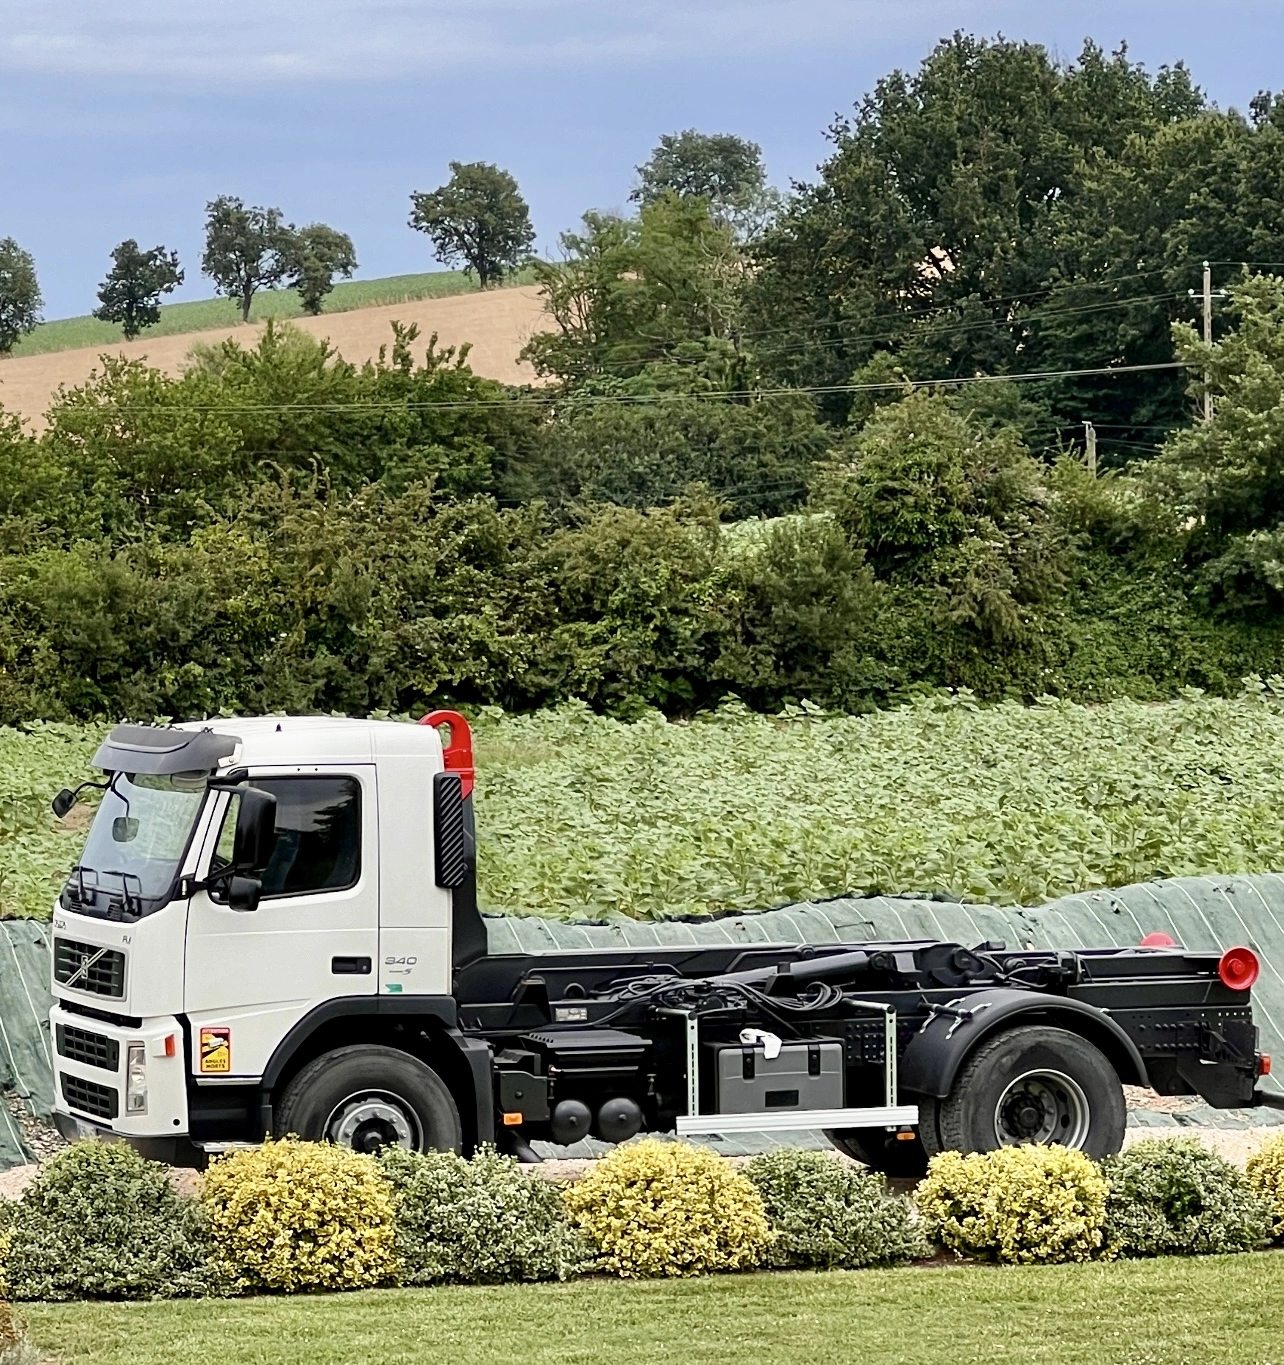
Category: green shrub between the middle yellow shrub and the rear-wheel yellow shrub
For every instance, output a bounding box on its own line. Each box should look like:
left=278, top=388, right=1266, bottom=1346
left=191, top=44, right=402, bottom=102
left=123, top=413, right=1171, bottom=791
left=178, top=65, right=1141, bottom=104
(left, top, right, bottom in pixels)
left=745, top=1148, right=932, bottom=1269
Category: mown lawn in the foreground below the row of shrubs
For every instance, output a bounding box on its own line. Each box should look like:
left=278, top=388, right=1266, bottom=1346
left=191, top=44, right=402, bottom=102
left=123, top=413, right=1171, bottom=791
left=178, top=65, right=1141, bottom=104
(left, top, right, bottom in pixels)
left=26, top=1253, right=1284, bottom=1365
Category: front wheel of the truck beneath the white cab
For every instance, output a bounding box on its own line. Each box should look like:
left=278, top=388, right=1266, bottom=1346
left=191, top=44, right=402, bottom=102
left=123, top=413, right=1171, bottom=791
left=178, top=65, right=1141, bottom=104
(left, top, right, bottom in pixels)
left=273, top=1044, right=464, bottom=1152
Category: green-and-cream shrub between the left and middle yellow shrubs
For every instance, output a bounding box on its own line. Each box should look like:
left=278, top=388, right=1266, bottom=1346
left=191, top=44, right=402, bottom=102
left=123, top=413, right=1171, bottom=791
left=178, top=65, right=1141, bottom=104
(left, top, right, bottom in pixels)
left=379, top=1147, right=587, bottom=1284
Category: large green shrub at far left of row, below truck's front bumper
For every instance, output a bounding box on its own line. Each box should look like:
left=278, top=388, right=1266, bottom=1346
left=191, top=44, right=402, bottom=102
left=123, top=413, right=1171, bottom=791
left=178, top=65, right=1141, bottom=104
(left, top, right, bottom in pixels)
left=5, top=1143, right=217, bottom=1299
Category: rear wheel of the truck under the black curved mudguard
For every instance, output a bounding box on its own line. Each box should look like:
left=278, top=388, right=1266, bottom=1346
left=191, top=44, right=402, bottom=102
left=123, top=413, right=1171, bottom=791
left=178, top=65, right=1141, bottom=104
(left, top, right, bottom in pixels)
left=936, top=1025, right=1126, bottom=1159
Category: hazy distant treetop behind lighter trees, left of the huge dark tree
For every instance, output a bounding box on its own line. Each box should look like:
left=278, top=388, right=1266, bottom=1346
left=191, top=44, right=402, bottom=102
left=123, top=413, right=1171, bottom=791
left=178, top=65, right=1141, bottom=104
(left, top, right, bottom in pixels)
left=629, top=128, right=779, bottom=236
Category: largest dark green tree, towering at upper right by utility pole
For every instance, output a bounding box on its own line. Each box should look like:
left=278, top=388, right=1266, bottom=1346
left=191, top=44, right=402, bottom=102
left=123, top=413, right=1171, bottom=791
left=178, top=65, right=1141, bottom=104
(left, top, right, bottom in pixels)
left=746, top=34, right=1211, bottom=442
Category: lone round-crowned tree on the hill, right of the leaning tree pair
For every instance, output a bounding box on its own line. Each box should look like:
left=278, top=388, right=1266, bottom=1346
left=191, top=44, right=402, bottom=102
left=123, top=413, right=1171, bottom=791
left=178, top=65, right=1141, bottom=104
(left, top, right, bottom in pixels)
left=409, top=161, right=535, bottom=289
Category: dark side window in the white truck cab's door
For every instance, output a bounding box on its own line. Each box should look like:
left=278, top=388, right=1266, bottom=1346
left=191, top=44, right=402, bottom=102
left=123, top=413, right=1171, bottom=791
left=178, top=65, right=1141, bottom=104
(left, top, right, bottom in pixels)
left=213, top=777, right=362, bottom=897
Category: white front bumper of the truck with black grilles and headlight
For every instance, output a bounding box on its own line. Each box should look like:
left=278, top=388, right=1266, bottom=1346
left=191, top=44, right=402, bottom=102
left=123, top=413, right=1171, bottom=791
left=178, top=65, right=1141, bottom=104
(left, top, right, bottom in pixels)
left=49, top=1005, right=187, bottom=1141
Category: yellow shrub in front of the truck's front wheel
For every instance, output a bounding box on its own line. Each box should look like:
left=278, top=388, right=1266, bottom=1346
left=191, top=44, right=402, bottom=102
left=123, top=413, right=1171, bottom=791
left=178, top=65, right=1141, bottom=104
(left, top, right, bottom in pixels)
left=201, top=1138, right=397, bottom=1293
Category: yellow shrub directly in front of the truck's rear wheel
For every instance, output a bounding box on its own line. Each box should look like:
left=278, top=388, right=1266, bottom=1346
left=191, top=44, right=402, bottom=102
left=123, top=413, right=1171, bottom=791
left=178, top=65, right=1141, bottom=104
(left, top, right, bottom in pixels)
left=914, top=1145, right=1109, bottom=1264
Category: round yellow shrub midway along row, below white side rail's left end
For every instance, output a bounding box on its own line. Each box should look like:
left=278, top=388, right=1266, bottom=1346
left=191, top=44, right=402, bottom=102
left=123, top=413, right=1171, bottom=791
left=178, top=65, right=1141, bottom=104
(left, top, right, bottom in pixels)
left=566, top=1138, right=772, bottom=1279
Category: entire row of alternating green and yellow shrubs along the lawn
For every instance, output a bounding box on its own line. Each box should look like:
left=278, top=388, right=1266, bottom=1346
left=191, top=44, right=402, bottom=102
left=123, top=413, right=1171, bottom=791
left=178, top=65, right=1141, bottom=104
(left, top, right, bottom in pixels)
left=0, top=1137, right=1284, bottom=1299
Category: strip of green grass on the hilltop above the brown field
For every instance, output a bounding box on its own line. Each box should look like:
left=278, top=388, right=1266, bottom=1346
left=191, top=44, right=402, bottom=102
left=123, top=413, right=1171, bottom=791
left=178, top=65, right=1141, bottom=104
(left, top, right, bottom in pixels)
left=14, top=270, right=529, bottom=355
